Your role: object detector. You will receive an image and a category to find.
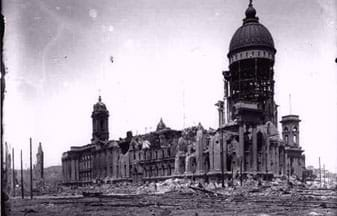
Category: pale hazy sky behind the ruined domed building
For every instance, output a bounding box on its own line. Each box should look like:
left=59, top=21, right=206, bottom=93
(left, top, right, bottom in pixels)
left=3, top=0, right=337, bottom=171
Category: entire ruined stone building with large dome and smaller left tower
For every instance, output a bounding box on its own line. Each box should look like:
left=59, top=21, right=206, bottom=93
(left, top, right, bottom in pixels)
left=62, top=3, right=305, bottom=185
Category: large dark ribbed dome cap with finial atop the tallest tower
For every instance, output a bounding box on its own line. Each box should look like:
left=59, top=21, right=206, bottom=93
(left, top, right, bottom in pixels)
left=229, top=4, right=276, bottom=54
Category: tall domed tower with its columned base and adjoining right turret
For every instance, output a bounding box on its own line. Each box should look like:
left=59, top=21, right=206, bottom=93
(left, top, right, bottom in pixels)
left=215, top=1, right=305, bottom=178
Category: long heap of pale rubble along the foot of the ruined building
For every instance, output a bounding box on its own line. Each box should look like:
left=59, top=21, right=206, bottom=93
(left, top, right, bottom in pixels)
left=56, top=176, right=337, bottom=202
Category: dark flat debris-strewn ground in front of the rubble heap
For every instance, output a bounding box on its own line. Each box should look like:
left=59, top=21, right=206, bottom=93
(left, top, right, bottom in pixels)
left=10, top=190, right=337, bottom=216
